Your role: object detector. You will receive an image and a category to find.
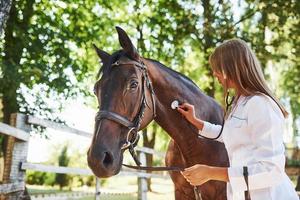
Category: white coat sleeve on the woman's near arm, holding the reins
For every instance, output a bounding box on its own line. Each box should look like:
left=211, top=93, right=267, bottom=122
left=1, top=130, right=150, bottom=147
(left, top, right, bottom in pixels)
left=228, top=96, right=285, bottom=192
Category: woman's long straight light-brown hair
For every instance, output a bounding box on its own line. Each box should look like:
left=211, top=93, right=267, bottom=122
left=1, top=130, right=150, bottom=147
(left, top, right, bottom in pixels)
left=209, top=39, right=288, bottom=117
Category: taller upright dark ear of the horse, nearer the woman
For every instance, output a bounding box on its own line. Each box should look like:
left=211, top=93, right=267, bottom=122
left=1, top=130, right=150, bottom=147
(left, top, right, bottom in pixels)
left=116, top=26, right=140, bottom=61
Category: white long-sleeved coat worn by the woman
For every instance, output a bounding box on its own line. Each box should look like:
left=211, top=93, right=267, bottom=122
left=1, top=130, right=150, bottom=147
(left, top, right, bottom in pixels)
left=199, top=94, right=299, bottom=200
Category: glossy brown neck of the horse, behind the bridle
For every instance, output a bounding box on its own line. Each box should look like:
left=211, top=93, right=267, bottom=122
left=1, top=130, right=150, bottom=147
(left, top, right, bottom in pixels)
left=145, top=60, right=218, bottom=164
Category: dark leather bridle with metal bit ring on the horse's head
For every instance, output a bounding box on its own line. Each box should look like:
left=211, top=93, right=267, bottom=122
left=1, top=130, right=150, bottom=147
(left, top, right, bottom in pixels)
left=96, top=57, right=156, bottom=165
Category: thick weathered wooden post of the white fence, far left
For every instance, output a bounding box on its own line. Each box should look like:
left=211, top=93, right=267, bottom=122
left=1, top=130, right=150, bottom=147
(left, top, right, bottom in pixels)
left=7, top=113, right=30, bottom=200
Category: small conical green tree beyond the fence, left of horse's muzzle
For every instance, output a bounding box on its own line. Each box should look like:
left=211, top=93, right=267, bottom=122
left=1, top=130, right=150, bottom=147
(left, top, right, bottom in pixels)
left=55, top=146, right=70, bottom=190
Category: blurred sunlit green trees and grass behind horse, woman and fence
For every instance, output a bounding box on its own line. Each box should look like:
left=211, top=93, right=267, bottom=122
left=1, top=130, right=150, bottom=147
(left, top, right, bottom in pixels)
left=0, top=0, right=300, bottom=199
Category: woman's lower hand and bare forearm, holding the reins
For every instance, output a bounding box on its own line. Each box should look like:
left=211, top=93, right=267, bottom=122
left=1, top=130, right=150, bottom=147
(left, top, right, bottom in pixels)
left=181, top=164, right=229, bottom=186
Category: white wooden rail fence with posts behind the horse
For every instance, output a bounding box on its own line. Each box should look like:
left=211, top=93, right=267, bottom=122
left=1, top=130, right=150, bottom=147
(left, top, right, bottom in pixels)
left=0, top=113, right=169, bottom=200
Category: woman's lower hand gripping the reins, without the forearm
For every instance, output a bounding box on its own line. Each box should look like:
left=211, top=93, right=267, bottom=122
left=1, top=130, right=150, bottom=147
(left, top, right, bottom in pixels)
left=181, top=164, right=212, bottom=186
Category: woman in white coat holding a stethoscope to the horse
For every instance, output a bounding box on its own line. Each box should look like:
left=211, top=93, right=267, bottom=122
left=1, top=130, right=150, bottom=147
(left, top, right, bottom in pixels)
left=177, top=39, right=299, bottom=200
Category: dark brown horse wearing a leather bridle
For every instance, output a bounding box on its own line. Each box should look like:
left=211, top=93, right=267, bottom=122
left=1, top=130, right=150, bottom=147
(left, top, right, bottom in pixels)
left=88, top=27, right=228, bottom=200
